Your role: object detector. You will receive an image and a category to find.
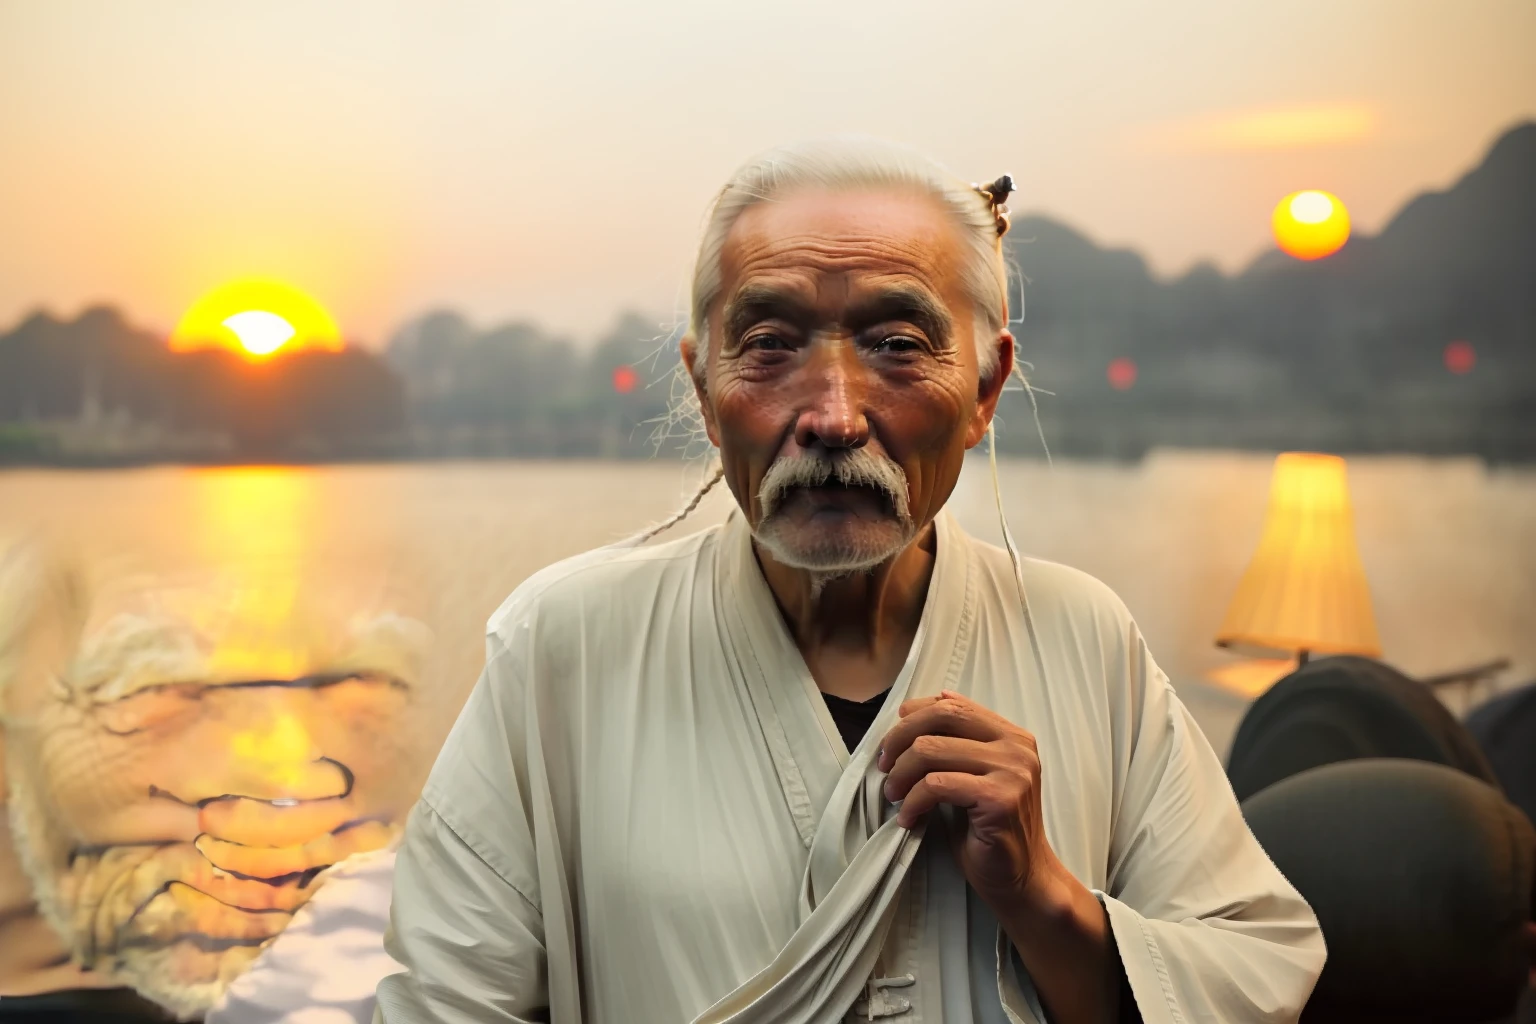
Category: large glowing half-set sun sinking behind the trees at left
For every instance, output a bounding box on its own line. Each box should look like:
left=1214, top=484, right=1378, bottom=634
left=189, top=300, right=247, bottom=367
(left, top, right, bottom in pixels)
left=170, top=278, right=344, bottom=359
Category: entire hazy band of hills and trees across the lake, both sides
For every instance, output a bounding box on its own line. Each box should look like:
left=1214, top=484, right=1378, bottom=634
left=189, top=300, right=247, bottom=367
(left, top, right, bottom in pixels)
left=0, top=124, right=1536, bottom=462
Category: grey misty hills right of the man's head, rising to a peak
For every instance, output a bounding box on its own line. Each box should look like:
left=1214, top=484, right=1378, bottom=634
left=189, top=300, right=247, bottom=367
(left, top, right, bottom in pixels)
left=1005, top=124, right=1536, bottom=459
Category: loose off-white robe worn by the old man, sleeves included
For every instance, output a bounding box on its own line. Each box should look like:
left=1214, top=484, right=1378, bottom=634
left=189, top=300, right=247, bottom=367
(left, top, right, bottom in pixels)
left=378, top=513, right=1324, bottom=1024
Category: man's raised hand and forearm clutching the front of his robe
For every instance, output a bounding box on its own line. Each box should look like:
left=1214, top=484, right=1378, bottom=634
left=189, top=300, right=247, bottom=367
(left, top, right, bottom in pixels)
left=879, top=689, right=1121, bottom=1022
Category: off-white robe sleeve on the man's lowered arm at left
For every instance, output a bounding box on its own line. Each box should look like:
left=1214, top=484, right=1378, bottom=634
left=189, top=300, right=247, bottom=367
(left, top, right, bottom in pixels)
left=375, top=643, right=550, bottom=1024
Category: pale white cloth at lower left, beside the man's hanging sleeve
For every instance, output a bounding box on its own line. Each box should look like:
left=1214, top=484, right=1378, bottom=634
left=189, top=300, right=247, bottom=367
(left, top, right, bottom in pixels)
left=203, top=849, right=399, bottom=1024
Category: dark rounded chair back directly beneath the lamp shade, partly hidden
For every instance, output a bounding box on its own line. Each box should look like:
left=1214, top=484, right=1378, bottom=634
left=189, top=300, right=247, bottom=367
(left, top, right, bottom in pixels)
left=1227, top=656, right=1498, bottom=800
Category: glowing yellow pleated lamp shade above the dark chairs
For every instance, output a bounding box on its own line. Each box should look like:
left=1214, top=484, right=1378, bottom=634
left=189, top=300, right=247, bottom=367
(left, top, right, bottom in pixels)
left=1217, top=451, right=1381, bottom=657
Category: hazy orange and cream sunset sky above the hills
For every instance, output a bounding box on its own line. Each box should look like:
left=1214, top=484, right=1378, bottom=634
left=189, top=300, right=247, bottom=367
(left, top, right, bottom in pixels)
left=0, top=0, right=1536, bottom=344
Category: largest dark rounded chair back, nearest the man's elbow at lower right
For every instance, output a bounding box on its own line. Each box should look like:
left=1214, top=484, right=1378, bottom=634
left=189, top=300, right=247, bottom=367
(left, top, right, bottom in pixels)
left=1243, top=758, right=1536, bottom=1024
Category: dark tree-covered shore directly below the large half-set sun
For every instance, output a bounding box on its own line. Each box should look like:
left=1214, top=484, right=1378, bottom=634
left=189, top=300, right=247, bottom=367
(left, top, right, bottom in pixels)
left=0, top=307, right=407, bottom=464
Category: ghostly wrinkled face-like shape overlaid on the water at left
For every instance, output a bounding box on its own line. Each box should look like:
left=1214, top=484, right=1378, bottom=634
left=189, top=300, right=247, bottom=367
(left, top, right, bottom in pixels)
left=0, top=553, right=430, bottom=1016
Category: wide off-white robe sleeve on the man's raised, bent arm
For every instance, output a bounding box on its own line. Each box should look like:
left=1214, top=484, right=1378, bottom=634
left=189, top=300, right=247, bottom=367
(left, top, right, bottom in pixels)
left=1095, top=629, right=1324, bottom=1024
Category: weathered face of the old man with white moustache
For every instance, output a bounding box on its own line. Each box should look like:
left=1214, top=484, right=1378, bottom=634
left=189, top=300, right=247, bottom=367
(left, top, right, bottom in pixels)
left=685, top=190, right=1012, bottom=573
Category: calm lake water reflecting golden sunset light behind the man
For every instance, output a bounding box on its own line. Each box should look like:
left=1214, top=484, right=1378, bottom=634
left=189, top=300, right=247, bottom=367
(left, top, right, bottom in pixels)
left=0, top=451, right=1536, bottom=751
